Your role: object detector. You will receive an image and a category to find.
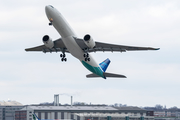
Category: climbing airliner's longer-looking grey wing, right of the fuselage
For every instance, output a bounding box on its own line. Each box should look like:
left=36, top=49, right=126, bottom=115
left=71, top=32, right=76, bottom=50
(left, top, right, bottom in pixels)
left=76, top=39, right=159, bottom=52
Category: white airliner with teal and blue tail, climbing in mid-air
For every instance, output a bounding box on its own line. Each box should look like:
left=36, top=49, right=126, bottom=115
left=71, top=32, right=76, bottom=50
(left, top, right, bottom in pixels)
left=25, top=5, right=160, bottom=79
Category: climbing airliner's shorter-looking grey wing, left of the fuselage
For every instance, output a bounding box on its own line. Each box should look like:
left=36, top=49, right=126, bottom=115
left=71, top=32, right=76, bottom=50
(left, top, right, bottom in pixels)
left=25, top=38, right=69, bottom=53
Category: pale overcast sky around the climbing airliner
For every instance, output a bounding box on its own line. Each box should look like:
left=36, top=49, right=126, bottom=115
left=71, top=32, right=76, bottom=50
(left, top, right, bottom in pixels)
left=0, top=0, right=180, bottom=108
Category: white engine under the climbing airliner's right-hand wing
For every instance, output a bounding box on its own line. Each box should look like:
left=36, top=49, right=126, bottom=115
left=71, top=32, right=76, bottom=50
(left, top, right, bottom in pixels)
left=84, top=34, right=96, bottom=48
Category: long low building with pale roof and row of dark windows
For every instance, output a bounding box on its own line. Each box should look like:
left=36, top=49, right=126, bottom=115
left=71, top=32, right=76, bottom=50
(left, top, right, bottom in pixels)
left=15, top=105, right=154, bottom=120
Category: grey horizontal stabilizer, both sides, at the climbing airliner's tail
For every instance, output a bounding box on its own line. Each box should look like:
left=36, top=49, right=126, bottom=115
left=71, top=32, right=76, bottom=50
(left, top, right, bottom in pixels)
left=86, top=72, right=126, bottom=78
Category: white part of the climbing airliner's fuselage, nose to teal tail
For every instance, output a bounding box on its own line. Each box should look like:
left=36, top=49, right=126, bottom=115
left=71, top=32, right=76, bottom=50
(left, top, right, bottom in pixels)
left=45, top=5, right=104, bottom=78
